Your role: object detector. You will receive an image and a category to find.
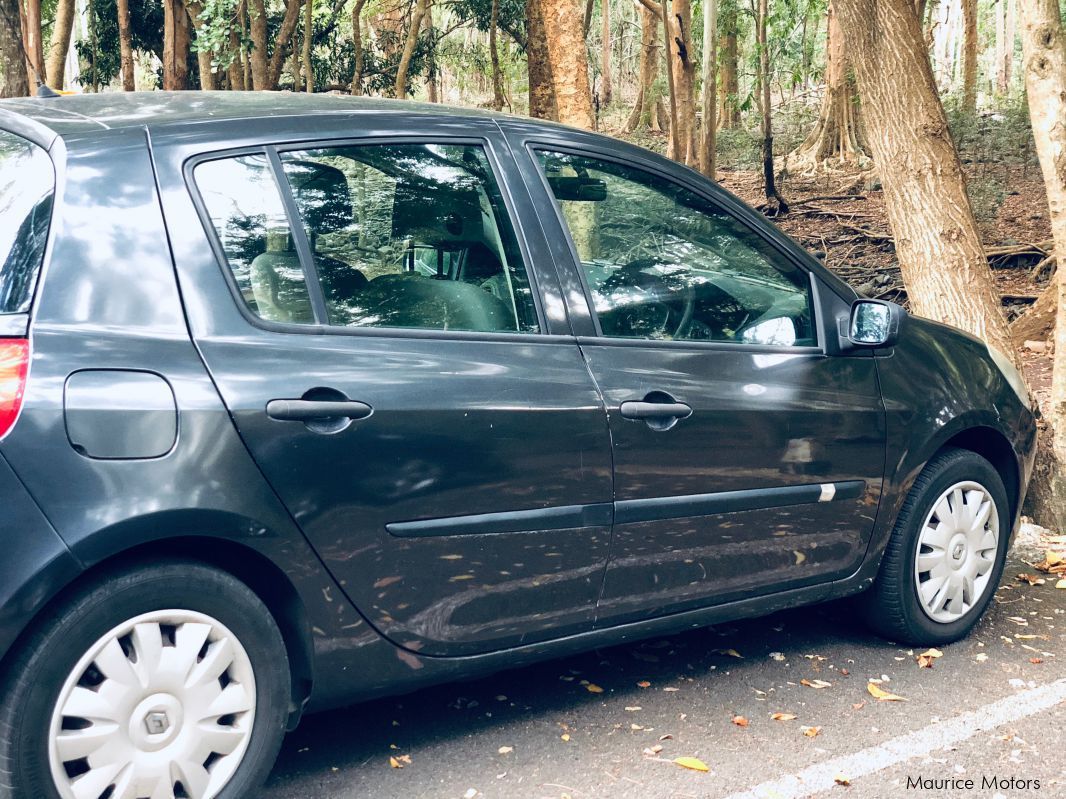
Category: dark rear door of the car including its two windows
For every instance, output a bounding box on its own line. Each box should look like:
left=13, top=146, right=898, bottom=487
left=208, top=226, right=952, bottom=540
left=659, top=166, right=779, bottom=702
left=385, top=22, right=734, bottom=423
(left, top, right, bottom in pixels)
left=154, top=125, right=612, bottom=655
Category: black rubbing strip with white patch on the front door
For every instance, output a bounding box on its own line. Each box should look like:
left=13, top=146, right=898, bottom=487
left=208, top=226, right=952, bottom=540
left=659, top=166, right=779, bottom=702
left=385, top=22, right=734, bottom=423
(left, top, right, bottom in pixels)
left=614, top=480, right=866, bottom=524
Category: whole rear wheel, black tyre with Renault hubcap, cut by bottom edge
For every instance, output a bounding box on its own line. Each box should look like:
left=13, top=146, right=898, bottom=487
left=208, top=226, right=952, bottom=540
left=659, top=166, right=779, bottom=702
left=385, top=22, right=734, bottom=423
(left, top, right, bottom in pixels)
left=0, top=561, right=291, bottom=799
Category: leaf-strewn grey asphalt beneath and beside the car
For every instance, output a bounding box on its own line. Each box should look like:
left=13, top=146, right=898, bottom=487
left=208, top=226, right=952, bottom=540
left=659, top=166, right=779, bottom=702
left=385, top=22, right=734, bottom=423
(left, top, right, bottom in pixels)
left=262, top=534, right=1066, bottom=799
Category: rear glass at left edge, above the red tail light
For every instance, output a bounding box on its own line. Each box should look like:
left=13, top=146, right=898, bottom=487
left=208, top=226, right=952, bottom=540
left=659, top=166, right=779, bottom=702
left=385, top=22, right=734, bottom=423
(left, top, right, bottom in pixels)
left=0, top=130, right=55, bottom=313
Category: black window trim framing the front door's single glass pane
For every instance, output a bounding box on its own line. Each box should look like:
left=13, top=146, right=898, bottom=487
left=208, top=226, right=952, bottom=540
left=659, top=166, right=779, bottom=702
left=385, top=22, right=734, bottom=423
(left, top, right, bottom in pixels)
left=522, top=142, right=826, bottom=355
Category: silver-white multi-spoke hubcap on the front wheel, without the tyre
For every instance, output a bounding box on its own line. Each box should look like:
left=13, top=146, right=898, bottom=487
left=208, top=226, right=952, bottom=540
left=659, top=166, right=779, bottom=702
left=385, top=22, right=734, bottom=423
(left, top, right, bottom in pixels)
left=915, top=480, right=1000, bottom=623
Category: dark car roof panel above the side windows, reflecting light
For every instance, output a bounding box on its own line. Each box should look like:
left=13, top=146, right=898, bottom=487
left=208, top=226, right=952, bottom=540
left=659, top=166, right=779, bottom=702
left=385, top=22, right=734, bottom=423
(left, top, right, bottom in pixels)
left=0, top=92, right=520, bottom=136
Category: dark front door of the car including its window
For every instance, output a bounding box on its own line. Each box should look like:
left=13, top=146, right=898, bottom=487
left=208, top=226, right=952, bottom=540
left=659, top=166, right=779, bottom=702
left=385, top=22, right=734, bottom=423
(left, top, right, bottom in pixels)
left=515, top=138, right=885, bottom=624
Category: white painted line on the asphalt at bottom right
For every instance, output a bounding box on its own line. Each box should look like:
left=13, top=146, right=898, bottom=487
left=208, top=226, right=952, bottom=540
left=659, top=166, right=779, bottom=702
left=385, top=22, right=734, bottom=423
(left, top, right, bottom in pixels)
left=726, top=679, right=1066, bottom=799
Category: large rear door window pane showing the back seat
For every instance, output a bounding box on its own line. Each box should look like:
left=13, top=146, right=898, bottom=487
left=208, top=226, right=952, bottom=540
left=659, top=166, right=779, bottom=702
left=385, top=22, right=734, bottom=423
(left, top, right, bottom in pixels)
left=281, top=144, right=538, bottom=332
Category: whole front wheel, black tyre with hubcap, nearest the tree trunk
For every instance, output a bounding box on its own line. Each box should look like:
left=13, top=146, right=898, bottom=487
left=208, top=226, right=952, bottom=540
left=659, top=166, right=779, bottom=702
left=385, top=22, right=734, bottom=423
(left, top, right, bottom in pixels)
left=859, top=450, right=1011, bottom=647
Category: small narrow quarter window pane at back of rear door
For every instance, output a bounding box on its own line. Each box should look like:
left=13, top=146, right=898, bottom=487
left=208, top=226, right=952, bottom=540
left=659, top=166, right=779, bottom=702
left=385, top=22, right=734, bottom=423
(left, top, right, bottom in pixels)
left=195, top=153, right=314, bottom=325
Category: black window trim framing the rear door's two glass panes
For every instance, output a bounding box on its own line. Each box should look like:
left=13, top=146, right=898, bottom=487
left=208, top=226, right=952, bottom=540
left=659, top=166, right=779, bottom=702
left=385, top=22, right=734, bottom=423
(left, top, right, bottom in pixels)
left=181, top=134, right=550, bottom=343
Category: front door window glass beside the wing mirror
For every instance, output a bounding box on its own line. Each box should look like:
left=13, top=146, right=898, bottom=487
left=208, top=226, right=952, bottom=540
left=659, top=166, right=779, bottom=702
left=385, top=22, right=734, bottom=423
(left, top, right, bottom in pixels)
left=537, top=151, right=815, bottom=346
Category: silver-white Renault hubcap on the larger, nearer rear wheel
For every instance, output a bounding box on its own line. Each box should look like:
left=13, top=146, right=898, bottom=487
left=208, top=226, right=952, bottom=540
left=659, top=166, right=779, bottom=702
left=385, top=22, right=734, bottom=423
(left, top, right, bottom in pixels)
left=48, top=610, right=256, bottom=799
